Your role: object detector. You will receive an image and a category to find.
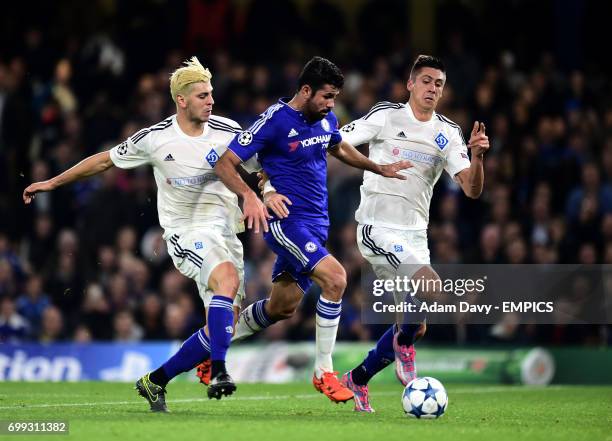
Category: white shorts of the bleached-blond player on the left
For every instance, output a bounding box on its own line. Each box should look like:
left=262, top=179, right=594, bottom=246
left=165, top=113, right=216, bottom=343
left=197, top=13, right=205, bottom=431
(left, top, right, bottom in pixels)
left=164, top=225, right=244, bottom=308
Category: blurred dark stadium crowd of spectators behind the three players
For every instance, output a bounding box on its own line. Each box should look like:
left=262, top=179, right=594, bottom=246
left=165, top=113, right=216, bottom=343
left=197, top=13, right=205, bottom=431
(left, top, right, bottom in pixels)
left=0, top=1, right=612, bottom=344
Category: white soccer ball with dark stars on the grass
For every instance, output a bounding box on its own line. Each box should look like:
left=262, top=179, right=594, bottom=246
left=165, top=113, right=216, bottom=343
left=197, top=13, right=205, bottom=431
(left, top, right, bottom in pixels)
left=402, top=377, right=448, bottom=418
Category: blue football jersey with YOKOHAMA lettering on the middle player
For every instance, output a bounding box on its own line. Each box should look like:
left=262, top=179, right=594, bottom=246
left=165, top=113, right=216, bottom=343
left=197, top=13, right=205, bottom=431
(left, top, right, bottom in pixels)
left=228, top=99, right=342, bottom=226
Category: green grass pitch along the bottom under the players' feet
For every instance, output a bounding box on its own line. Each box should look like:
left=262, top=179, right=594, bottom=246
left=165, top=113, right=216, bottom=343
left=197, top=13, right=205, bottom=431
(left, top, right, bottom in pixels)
left=0, top=382, right=612, bottom=441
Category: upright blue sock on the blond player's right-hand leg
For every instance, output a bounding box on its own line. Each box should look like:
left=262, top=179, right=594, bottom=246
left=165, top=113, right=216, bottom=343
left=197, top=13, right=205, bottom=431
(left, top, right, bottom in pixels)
left=208, top=295, right=234, bottom=362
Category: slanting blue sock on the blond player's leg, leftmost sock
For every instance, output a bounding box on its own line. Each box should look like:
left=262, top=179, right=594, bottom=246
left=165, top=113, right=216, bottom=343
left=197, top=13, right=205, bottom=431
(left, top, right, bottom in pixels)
left=157, top=328, right=210, bottom=386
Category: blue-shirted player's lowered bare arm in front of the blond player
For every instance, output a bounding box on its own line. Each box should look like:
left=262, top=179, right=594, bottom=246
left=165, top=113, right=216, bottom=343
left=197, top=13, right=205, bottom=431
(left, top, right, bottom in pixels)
left=215, top=150, right=271, bottom=233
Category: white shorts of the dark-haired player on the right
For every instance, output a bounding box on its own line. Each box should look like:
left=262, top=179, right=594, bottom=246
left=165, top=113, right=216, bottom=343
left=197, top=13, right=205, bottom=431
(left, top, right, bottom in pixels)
left=357, top=224, right=430, bottom=279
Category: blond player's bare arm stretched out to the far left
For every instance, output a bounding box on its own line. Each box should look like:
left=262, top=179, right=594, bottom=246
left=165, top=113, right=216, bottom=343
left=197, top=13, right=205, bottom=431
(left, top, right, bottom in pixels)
left=23, top=151, right=114, bottom=204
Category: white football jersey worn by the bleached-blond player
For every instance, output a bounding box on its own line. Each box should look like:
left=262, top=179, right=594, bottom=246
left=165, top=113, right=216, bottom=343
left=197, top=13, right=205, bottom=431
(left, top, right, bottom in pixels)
left=110, top=115, right=261, bottom=237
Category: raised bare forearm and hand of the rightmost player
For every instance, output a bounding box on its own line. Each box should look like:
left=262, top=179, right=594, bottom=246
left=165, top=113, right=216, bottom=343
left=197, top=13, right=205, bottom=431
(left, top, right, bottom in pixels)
left=456, top=121, right=489, bottom=199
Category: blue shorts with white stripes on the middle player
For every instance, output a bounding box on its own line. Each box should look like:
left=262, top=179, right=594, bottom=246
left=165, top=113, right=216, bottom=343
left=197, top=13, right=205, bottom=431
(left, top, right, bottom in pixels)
left=264, top=220, right=329, bottom=292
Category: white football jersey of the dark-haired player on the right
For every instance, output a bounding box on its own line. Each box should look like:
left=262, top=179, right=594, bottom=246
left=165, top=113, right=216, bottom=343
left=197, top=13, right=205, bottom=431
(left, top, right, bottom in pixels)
left=340, top=102, right=470, bottom=230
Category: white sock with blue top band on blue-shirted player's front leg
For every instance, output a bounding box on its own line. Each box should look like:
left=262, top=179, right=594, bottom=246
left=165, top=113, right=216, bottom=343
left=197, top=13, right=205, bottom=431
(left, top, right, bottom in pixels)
left=315, top=297, right=342, bottom=378
